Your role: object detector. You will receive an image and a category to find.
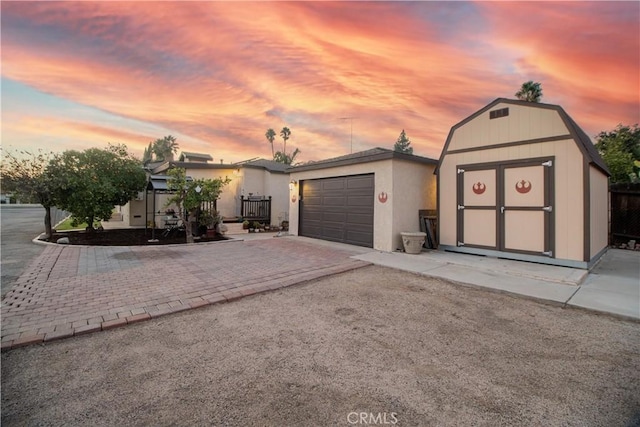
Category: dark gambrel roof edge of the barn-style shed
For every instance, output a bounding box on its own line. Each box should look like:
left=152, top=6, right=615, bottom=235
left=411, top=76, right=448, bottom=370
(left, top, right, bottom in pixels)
left=435, top=98, right=611, bottom=175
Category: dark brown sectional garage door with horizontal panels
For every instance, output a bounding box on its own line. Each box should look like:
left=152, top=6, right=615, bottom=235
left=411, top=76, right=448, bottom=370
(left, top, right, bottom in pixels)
left=300, top=174, right=374, bottom=248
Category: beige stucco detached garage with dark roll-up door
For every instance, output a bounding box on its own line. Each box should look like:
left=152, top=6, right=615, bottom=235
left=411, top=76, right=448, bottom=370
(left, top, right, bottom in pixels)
left=289, top=148, right=437, bottom=252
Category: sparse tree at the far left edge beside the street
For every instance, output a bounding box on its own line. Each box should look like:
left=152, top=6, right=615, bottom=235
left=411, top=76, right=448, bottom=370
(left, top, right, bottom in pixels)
left=0, top=150, right=55, bottom=239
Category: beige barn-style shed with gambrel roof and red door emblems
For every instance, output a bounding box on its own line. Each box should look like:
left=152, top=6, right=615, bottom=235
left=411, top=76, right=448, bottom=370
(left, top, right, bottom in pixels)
left=436, top=98, right=610, bottom=268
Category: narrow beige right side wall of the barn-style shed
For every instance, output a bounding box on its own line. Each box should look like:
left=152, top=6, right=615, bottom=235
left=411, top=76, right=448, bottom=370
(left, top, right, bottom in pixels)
left=589, top=166, right=609, bottom=257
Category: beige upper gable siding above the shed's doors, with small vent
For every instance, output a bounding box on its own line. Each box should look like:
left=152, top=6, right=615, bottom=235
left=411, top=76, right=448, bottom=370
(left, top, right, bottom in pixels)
left=448, top=104, right=569, bottom=151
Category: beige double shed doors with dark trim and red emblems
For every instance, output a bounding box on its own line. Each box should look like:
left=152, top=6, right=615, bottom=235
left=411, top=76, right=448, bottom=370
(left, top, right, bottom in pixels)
left=458, top=159, right=553, bottom=257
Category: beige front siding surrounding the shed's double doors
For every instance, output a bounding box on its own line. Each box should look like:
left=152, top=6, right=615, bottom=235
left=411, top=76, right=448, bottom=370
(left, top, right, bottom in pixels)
left=439, top=139, right=584, bottom=261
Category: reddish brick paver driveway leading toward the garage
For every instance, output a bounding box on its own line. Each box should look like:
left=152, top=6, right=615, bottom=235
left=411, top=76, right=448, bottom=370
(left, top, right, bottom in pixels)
left=0, top=238, right=368, bottom=350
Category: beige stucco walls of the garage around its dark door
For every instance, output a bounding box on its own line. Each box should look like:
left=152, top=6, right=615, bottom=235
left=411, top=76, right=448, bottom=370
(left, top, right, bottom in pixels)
left=289, top=159, right=436, bottom=252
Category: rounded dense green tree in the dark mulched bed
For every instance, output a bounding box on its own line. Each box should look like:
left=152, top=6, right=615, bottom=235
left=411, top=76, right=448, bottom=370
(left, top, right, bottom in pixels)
left=46, top=144, right=146, bottom=230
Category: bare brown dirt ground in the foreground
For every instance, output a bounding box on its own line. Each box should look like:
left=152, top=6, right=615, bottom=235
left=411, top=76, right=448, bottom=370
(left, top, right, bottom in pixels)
left=2, top=266, right=640, bottom=426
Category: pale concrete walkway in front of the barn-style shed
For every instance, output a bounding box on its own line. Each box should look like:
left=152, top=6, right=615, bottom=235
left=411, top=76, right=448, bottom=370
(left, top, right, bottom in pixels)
left=354, top=249, right=640, bottom=319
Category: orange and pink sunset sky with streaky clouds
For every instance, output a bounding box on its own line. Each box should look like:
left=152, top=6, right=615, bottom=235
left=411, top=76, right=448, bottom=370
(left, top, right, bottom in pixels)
left=1, top=1, right=640, bottom=163
